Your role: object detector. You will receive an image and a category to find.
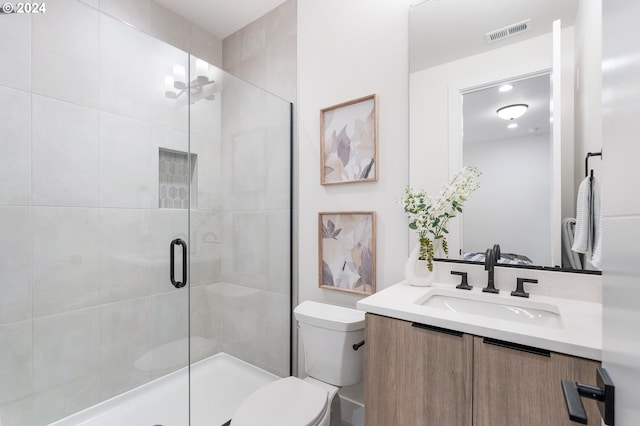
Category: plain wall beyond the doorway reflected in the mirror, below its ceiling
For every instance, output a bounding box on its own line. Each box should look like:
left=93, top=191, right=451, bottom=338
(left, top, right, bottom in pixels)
left=463, top=133, right=551, bottom=265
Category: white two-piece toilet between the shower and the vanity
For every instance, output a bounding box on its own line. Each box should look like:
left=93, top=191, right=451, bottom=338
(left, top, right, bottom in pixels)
left=231, top=301, right=364, bottom=426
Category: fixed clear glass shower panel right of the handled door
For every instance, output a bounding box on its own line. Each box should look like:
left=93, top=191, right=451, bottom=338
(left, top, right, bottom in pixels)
left=189, top=56, right=292, bottom=426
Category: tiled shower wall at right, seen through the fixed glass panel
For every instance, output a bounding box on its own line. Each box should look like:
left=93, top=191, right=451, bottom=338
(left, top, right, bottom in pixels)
left=222, top=75, right=291, bottom=376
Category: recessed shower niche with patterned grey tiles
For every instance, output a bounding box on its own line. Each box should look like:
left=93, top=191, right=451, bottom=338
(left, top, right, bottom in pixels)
left=158, top=148, right=198, bottom=209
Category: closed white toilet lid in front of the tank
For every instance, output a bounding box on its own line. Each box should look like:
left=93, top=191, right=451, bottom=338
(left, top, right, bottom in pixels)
left=231, top=377, right=328, bottom=426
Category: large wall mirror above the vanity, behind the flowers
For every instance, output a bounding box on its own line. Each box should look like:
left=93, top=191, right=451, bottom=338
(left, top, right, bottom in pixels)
left=410, top=0, right=596, bottom=269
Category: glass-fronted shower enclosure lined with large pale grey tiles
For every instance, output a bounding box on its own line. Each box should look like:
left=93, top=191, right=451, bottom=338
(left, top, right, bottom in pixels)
left=0, top=0, right=291, bottom=426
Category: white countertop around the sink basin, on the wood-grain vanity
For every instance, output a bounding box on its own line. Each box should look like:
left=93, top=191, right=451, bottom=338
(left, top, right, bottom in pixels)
left=356, top=281, right=602, bottom=361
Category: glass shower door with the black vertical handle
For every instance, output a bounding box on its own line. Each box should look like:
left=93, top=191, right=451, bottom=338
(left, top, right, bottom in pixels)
left=0, top=4, right=192, bottom=426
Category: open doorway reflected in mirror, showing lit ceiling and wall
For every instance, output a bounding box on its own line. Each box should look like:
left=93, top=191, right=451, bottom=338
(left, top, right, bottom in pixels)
left=462, top=73, right=552, bottom=265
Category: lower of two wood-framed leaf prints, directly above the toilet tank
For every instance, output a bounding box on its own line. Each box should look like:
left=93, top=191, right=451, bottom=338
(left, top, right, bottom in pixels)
left=318, top=211, right=376, bottom=295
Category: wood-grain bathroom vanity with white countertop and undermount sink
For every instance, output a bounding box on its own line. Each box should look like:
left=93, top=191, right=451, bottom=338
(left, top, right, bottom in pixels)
left=358, top=282, right=602, bottom=426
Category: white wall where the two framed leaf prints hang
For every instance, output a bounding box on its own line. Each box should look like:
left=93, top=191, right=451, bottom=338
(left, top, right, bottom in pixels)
left=297, top=0, right=409, bottom=307
